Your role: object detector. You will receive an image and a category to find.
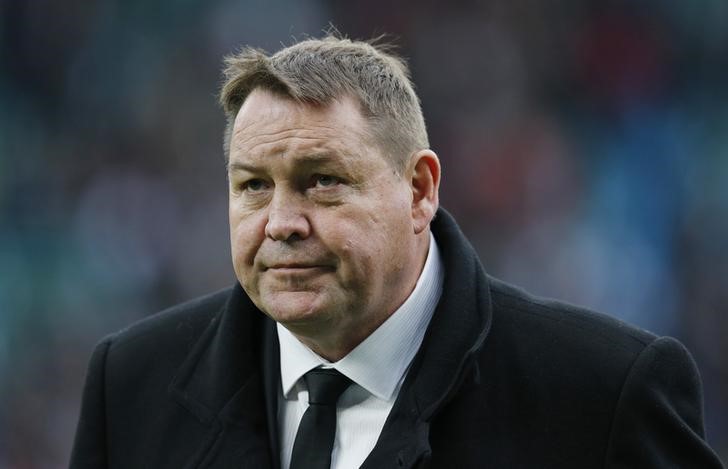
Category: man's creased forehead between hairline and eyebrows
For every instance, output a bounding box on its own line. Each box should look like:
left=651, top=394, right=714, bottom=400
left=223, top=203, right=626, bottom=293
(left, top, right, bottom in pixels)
left=230, top=89, right=367, bottom=160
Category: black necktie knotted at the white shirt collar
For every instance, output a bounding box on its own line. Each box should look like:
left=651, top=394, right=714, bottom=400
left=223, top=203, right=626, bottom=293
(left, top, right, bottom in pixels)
left=290, top=368, right=351, bottom=469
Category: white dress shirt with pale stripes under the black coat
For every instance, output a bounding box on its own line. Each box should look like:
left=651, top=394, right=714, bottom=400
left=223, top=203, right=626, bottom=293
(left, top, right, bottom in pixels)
left=277, top=234, right=444, bottom=469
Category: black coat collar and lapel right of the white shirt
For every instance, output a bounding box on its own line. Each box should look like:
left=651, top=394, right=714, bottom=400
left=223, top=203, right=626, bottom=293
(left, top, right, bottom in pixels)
left=362, top=209, right=492, bottom=469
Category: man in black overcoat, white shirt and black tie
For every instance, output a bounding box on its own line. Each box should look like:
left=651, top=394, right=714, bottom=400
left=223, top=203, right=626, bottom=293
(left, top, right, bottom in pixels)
left=71, top=37, right=721, bottom=469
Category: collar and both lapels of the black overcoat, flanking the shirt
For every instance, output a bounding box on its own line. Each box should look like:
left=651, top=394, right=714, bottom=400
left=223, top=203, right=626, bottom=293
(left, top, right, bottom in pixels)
left=169, top=209, right=492, bottom=468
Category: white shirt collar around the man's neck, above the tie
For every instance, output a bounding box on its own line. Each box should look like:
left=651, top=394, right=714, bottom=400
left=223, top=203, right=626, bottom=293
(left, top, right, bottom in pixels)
left=277, top=233, right=444, bottom=400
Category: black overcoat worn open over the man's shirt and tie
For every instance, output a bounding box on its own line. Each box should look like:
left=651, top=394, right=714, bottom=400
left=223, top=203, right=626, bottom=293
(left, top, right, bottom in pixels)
left=71, top=210, right=721, bottom=469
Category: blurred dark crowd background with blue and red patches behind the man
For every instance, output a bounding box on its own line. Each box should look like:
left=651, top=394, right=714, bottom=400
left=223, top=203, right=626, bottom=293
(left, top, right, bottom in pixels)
left=0, top=0, right=728, bottom=468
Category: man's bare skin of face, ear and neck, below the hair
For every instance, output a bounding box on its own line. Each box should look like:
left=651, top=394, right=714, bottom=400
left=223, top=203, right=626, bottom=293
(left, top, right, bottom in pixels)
left=228, top=89, right=440, bottom=361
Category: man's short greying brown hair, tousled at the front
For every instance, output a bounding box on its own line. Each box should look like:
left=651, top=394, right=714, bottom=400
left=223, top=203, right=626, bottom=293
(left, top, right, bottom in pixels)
left=220, top=35, right=429, bottom=172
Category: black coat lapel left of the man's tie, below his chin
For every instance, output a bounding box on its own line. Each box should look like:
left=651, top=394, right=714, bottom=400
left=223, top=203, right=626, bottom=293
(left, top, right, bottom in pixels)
left=169, top=285, right=277, bottom=469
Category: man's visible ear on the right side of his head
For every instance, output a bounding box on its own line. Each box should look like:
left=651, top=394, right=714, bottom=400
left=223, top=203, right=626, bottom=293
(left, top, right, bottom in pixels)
left=408, top=150, right=440, bottom=234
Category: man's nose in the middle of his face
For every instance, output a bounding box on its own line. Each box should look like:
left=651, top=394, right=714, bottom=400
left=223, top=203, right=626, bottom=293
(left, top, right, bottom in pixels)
left=265, top=191, right=311, bottom=241
